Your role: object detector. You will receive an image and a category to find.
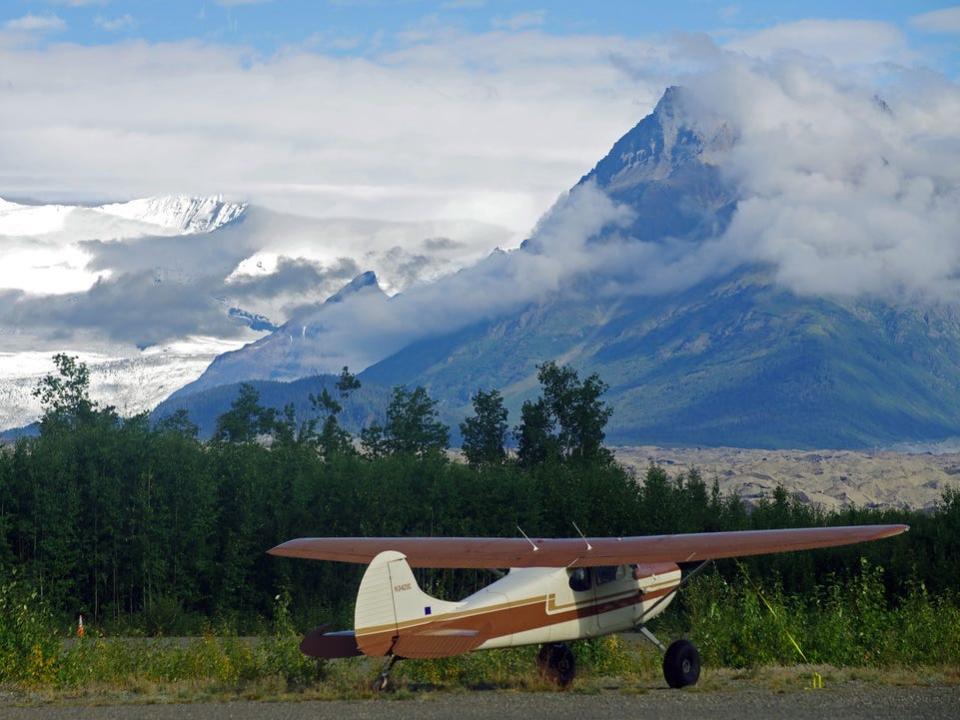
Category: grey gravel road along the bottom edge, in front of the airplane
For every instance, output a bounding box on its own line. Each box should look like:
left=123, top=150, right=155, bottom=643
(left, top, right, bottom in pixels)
left=0, top=684, right=960, bottom=720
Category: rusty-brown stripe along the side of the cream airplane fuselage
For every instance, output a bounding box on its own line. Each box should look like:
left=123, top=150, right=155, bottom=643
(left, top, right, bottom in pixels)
left=356, top=583, right=679, bottom=655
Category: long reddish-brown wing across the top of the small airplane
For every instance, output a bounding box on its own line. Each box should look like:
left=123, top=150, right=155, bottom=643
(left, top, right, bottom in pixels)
left=268, top=525, right=910, bottom=568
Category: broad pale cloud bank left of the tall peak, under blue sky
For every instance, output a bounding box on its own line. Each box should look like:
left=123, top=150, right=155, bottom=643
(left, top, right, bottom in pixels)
left=0, top=32, right=663, bottom=238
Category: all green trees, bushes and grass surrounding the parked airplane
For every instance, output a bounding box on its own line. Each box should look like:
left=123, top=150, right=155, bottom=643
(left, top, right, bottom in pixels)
left=0, top=356, right=960, bottom=694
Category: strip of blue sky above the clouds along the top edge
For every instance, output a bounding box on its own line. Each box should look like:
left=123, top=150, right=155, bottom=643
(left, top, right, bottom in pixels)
left=0, top=0, right=960, bottom=76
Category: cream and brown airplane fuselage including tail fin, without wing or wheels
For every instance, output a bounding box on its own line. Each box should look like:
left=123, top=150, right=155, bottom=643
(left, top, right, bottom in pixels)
left=354, top=551, right=680, bottom=657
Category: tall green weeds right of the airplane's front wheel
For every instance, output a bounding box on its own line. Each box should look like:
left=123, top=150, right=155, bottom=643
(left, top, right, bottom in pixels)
left=685, top=560, right=960, bottom=667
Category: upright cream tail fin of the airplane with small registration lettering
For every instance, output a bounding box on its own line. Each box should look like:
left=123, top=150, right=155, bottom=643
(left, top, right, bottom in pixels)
left=353, top=550, right=458, bottom=657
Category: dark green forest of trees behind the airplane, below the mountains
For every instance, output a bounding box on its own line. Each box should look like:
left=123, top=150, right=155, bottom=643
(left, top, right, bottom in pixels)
left=0, top=355, right=960, bottom=633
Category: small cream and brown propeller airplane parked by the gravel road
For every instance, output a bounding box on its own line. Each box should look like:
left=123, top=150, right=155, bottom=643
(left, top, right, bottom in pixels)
left=268, top=525, right=909, bottom=690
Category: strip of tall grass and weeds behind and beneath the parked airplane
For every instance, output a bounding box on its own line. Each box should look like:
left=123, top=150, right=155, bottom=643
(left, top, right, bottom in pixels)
left=0, top=561, right=960, bottom=695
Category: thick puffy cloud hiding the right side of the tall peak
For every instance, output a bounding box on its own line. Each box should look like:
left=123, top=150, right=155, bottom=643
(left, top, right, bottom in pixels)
left=676, top=54, right=960, bottom=302
